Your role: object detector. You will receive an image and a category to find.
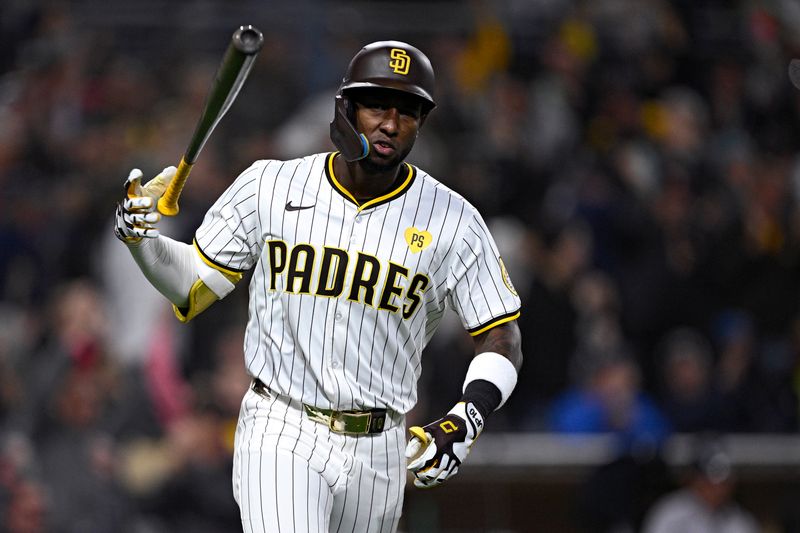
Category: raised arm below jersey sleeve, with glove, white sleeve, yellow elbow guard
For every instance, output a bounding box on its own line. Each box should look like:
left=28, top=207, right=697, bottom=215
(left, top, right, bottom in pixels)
left=114, top=167, right=241, bottom=322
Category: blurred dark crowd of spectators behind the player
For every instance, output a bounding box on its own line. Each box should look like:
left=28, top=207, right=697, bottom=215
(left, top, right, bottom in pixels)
left=0, top=0, right=800, bottom=533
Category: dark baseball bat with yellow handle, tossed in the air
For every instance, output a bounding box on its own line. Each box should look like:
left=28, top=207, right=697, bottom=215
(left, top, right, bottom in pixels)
left=158, top=25, right=264, bottom=216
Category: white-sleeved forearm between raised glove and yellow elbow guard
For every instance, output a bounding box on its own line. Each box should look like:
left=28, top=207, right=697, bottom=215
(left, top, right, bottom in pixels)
left=128, top=235, right=198, bottom=307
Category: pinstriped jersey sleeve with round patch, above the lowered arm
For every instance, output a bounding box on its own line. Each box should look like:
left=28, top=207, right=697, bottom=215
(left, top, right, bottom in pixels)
left=448, top=212, right=521, bottom=336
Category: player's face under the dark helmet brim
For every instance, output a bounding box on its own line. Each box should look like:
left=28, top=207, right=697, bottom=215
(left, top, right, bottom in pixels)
left=355, top=89, right=423, bottom=169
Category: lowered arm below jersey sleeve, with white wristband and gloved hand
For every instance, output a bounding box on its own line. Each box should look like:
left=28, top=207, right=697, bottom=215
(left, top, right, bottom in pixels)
left=406, top=320, right=522, bottom=488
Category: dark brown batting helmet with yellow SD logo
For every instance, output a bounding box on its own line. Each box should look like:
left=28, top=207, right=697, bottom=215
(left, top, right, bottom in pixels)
left=330, top=41, right=436, bottom=161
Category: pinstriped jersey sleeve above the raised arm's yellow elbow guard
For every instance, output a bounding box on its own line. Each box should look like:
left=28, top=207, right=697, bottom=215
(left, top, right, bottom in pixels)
left=194, top=161, right=265, bottom=273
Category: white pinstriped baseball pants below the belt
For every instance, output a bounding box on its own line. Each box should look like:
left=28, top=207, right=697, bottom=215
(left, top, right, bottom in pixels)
left=233, top=389, right=406, bottom=533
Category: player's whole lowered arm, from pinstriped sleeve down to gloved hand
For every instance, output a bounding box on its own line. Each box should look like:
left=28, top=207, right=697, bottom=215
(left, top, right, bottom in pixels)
left=406, top=210, right=522, bottom=487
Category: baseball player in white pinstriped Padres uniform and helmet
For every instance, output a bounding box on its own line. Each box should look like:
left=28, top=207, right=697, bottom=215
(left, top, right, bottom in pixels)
left=115, top=41, right=522, bottom=532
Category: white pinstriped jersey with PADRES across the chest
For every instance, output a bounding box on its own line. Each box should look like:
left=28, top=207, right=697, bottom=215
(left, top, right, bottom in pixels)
left=195, top=153, right=520, bottom=413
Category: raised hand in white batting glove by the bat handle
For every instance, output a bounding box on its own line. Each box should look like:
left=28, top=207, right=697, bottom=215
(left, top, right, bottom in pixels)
left=114, top=167, right=177, bottom=244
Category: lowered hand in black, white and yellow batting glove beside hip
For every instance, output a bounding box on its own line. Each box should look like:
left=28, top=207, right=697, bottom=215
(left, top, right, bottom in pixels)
left=406, top=402, right=483, bottom=488
